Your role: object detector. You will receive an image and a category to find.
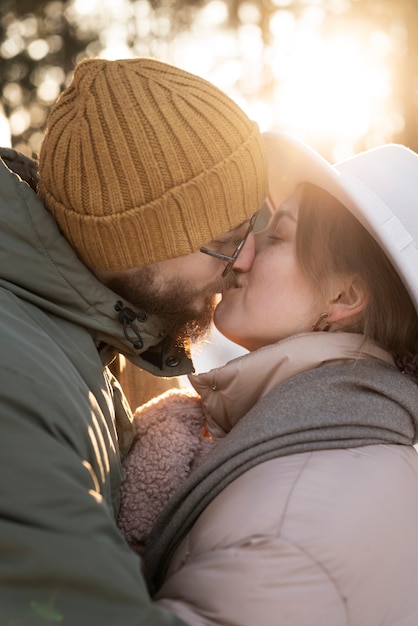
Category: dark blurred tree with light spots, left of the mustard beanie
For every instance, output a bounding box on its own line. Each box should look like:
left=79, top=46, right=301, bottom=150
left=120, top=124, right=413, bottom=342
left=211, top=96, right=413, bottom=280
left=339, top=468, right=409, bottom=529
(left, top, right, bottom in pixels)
left=0, top=0, right=89, bottom=154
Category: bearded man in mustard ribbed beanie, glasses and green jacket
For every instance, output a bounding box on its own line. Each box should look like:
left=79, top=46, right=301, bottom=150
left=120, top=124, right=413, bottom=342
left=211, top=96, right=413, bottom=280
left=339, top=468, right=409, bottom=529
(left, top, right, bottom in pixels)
left=0, top=59, right=266, bottom=626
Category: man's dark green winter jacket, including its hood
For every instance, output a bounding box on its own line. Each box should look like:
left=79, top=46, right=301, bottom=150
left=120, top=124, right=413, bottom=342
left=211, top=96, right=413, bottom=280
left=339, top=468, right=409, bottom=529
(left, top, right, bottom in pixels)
left=0, top=160, right=191, bottom=626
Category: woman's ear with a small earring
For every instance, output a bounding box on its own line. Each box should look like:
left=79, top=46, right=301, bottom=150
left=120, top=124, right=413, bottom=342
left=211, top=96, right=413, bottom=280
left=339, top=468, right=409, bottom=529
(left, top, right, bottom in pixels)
left=327, top=274, right=368, bottom=325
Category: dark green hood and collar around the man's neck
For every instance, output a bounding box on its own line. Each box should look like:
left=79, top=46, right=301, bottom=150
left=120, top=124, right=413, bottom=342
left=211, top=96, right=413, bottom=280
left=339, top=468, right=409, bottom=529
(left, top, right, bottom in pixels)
left=0, top=159, right=193, bottom=376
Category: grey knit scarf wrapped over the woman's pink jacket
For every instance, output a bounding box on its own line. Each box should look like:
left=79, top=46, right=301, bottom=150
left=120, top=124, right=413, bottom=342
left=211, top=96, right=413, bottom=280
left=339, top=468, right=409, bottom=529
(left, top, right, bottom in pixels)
left=145, top=359, right=418, bottom=593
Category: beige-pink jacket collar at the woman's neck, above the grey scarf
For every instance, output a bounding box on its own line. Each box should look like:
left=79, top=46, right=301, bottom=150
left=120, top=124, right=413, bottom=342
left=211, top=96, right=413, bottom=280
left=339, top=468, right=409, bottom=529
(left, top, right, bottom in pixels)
left=189, top=332, right=394, bottom=438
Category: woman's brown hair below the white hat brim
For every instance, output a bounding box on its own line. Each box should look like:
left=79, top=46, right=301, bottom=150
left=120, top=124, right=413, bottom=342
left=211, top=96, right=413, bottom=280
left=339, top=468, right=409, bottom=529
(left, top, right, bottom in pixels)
left=296, top=183, right=418, bottom=357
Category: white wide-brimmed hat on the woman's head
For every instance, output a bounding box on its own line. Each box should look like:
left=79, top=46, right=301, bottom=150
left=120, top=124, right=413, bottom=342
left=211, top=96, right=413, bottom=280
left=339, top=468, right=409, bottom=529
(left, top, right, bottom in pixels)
left=263, top=132, right=418, bottom=312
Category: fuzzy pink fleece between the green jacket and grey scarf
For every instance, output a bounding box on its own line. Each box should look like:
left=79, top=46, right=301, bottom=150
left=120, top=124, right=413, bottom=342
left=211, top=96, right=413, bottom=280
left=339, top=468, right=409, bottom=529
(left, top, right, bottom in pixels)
left=118, top=389, right=215, bottom=554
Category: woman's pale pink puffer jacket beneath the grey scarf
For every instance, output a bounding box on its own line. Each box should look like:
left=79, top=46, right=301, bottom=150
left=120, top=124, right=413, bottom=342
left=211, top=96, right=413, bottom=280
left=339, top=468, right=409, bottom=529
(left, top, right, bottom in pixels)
left=147, top=338, right=418, bottom=626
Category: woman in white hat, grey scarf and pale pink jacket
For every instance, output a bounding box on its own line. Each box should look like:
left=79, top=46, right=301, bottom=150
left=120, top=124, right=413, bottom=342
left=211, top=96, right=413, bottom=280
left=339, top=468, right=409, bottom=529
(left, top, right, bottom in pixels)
left=119, top=133, right=418, bottom=626
